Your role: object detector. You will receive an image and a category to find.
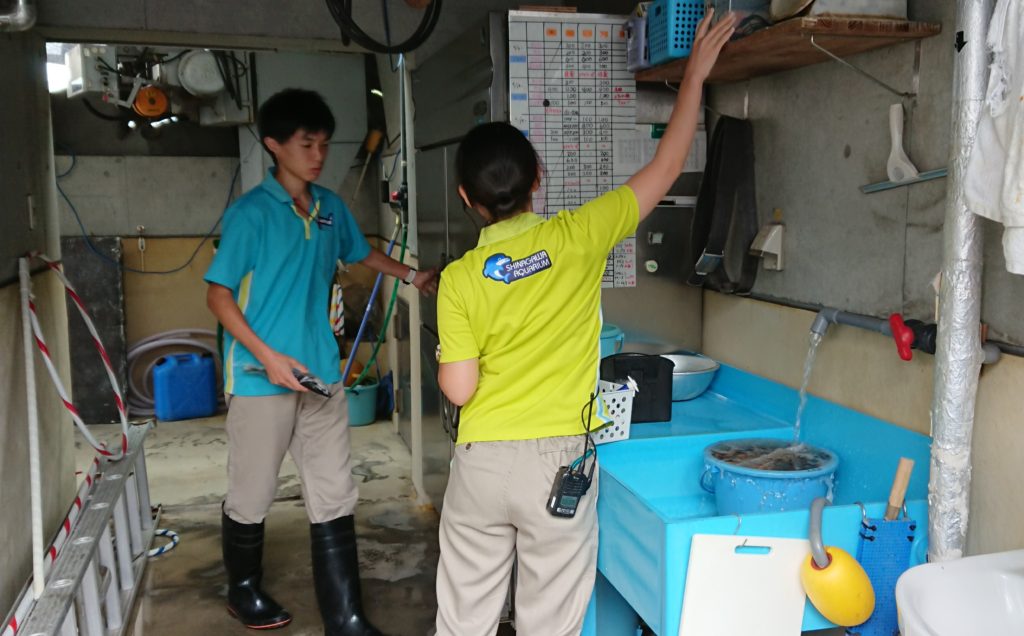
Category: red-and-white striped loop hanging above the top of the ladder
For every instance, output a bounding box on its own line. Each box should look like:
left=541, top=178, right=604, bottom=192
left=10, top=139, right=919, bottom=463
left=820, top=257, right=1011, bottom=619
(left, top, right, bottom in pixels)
left=29, top=252, right=128, bottom=461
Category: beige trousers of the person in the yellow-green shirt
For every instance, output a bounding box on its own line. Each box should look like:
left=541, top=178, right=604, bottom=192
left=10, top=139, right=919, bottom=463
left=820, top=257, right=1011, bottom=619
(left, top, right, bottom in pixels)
left=436, top=436, right=598, bottom=636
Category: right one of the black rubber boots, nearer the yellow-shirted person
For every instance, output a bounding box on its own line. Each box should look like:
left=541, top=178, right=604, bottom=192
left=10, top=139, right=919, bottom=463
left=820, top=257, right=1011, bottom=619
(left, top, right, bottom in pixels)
left=309, top=515, right=384, bottom=636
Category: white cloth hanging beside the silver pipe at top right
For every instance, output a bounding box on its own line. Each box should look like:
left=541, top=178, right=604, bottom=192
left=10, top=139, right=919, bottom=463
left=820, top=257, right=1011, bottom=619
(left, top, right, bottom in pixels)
left=965, top=0, right=1024, bottom=274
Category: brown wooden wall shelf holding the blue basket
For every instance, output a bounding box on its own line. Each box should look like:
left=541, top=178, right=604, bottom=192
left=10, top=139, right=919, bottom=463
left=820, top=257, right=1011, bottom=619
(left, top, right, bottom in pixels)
left=636, top=17, right=942, bottom=84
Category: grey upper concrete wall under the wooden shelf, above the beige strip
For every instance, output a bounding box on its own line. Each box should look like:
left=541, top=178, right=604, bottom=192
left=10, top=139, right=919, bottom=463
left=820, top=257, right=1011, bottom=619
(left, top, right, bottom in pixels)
left=710, top=0, right=1024, bottom=343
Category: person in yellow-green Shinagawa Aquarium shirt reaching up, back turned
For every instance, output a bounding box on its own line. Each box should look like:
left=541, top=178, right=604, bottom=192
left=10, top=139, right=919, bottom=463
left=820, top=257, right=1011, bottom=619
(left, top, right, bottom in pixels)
left=436, top=12, right=734, bottom=636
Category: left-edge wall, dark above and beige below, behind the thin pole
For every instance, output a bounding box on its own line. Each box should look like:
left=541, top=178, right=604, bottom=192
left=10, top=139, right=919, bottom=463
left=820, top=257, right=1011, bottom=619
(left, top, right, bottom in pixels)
left=0, top=34, right=75, bottom=613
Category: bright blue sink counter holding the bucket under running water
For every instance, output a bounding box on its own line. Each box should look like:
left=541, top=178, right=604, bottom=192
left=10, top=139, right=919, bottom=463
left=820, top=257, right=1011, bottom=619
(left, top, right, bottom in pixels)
left=584, top=365, right=931, bottom=636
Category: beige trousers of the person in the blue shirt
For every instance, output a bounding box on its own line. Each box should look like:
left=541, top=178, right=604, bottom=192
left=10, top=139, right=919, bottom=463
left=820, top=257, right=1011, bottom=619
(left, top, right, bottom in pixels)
left=224, top=382, right=359, bottom=523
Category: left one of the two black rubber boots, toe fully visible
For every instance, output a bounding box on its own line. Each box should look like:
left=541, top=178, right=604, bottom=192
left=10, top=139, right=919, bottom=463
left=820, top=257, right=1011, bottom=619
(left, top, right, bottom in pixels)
left=220, top=511, right=292, bottom=630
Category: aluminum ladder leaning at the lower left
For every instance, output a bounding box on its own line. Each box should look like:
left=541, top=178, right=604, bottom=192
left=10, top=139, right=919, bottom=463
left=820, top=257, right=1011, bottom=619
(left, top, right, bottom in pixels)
left=17, top=422, right=160, bottom=636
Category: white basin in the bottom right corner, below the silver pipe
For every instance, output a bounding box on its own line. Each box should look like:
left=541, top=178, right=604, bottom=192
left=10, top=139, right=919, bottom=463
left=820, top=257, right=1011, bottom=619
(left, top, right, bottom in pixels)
left=896, top=550, right=1024, bottom=636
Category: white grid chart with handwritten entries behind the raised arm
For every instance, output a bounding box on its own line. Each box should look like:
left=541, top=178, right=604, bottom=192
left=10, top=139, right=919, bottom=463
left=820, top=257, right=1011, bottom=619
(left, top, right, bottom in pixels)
left=509, top=11, right=642, bottom=288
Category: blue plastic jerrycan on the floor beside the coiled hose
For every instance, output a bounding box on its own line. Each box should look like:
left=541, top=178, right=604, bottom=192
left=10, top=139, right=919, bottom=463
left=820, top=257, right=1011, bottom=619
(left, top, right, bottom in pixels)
left=153, top=353, right=217, bottom=421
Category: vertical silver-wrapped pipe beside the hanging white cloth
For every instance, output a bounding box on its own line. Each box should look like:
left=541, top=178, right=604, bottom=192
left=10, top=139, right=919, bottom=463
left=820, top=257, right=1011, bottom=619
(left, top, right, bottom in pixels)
left=928, top=0, right=992, bottom=561
